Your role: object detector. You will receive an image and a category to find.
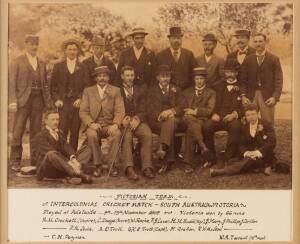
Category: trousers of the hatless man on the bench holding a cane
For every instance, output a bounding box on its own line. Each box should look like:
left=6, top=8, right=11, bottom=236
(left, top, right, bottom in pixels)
left=121, top=123, right=153, bottom=170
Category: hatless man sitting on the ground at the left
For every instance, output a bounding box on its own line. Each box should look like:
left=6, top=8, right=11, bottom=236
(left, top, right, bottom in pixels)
left=34, top=110, right=92, bottom=184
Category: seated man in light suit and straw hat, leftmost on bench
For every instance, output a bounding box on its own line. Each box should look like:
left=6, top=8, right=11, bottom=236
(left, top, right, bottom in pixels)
left=79, top=66, right=125, bottom=177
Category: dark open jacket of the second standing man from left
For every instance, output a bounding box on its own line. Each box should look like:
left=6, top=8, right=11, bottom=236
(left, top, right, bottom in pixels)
left=51, top=60, right=89, bottom=102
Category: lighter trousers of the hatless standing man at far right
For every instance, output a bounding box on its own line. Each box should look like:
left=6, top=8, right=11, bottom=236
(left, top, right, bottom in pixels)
left=253, top=90, right=275, bottom=125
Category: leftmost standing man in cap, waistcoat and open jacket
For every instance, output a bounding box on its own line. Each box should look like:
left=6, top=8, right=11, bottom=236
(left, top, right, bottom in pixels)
left=9, top=35, right=52, bottom=171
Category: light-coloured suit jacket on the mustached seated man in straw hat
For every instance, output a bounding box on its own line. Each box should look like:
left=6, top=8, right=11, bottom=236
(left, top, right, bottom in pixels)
left=79, top=84, right=125, bottom=126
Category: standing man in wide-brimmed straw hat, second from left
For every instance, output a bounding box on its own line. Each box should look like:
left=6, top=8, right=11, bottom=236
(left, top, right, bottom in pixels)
left=51, top=39, right=89, bottom=150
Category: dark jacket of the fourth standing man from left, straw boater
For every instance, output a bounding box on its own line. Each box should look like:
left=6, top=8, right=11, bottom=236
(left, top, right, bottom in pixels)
left=117, top=47, right=155, bottom=87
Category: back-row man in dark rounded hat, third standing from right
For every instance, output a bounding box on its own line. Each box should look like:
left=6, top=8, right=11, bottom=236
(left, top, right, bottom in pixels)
left=197, top=33, right=224, bottom=89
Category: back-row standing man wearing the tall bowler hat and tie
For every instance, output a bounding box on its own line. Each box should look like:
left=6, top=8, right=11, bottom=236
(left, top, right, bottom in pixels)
left=156, top=27, right=197, bottom=89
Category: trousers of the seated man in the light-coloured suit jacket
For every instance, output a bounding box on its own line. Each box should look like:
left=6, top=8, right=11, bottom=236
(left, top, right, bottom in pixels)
left=83, top=126, right=121, bottom=166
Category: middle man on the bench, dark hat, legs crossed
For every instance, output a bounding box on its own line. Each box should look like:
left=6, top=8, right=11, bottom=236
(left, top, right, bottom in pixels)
left=146, top=65, right=185, bottom=173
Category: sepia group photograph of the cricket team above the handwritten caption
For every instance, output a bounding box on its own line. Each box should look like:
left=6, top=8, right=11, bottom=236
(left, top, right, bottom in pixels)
left=7, top=1, right=293, bottom=189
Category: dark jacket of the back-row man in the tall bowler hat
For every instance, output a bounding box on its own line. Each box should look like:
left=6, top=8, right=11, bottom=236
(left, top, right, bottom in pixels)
left=156, top=48, right=197, bottom=89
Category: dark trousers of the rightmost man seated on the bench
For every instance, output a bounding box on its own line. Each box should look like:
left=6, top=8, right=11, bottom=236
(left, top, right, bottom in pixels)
left=203, top=119, right=241, bottom=161
